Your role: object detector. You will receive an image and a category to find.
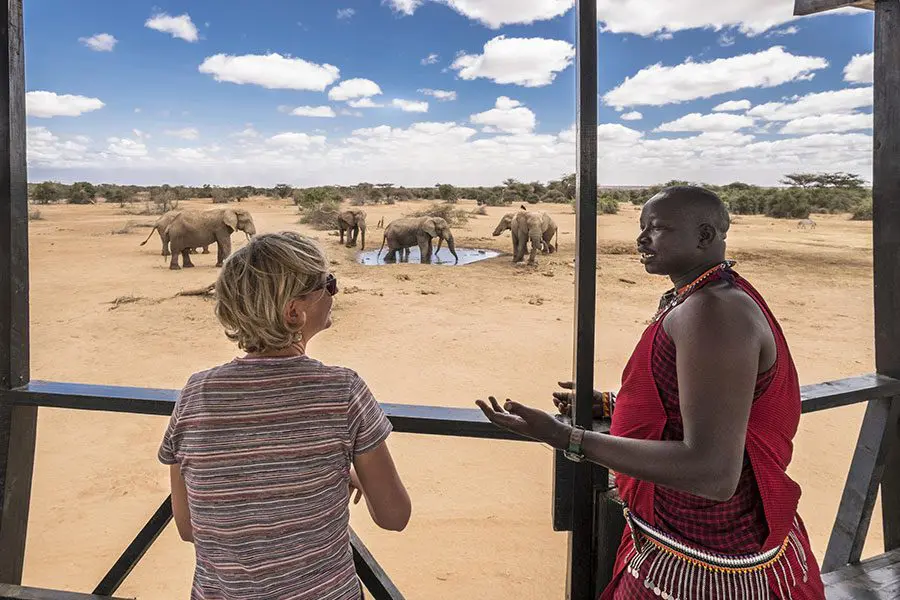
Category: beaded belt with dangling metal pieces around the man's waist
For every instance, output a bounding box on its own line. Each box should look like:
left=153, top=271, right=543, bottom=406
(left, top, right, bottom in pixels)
left=624, top=507, right=809, bottom=600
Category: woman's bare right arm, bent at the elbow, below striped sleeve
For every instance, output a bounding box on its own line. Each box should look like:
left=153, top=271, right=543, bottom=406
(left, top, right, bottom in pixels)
left=353, top=441, right=412, bottom=531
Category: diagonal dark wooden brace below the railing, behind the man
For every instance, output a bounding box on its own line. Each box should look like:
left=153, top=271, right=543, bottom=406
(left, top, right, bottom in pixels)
left=822, top=396, right=900, bottom=573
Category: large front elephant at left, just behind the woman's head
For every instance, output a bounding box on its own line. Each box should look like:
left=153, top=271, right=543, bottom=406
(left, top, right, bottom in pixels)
left=165, top=208, right=256, bottom=269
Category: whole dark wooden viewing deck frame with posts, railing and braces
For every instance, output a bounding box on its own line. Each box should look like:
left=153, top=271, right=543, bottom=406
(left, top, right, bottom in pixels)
left=0, top=0, right=900, bottom=600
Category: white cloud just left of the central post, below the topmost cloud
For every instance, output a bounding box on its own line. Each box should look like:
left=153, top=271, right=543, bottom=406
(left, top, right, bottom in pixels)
left=450, top=35, right=575, bottom=87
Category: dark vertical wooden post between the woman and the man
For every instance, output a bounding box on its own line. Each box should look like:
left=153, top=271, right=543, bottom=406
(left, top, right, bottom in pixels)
left=566, top=0, right=597, bottom=600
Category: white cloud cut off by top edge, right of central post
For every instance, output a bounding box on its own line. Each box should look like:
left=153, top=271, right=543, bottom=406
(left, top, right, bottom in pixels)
left=597, top=0, right=859, bottom=36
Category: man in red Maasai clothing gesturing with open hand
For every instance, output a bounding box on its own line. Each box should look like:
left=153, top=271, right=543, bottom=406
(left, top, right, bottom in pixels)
left=476, top=186, right=825, bottom=600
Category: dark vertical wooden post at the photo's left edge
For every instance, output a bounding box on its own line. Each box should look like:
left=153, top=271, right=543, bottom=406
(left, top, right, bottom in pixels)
left=0, top=0, right=37, bottom=584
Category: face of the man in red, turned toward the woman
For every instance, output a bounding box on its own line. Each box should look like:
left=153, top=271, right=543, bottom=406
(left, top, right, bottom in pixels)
left=637, top=194, right=703, bottom=276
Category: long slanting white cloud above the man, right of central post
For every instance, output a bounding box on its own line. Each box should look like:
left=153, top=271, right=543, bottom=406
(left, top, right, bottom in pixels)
left=603, top=46, right=828, bottom=107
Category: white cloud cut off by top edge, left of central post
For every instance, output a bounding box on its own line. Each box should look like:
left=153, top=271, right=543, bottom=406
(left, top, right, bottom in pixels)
left=382, top=0, right=574, bottom=29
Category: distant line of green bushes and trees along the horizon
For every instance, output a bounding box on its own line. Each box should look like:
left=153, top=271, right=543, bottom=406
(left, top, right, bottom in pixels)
left=28, top=172, right=872, bottom=219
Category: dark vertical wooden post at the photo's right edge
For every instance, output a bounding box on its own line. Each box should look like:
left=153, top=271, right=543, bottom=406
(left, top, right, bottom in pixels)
left=872, top=0, right=900, bottom=550
